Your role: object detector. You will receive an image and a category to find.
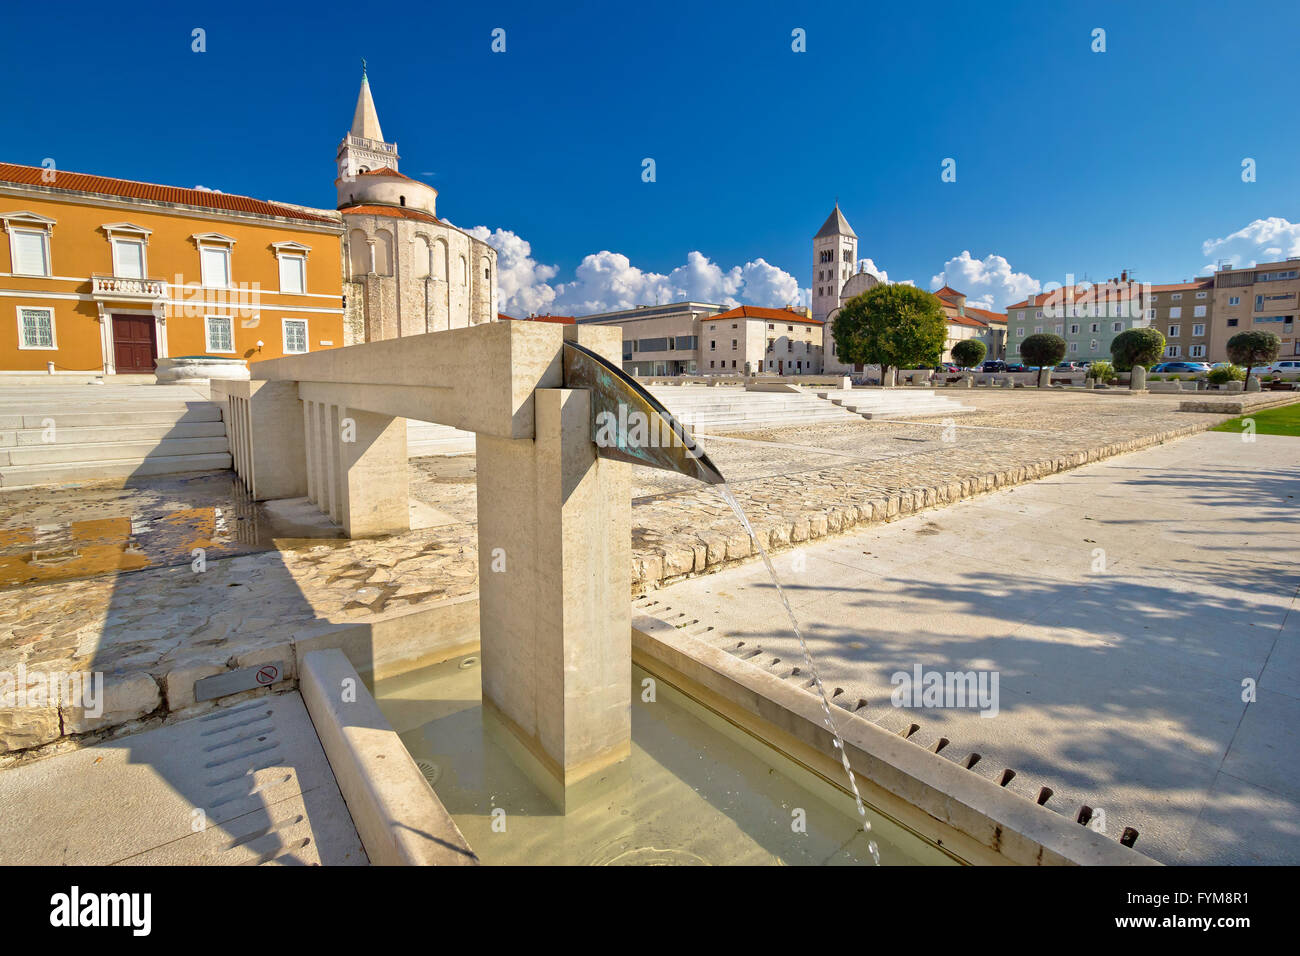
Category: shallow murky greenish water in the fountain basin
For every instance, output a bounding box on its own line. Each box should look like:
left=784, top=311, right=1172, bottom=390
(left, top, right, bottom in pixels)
left=374, top=658, right=954, bottom=865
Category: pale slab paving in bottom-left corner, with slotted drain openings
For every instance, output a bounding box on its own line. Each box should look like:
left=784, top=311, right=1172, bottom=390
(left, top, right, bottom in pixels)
left=0, top=693, right=367, bottom=866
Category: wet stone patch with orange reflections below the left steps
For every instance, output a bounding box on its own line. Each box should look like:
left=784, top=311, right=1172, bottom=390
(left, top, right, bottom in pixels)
left=0, top=475, right=347, bottom=589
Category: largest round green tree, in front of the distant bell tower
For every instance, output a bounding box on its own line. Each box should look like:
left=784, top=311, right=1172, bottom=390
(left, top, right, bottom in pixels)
left=831, top=285, right=948, bottom=381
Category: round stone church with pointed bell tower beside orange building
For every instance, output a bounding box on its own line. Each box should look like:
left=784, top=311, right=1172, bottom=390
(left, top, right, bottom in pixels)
left=334, top=69, right=497, bottom=345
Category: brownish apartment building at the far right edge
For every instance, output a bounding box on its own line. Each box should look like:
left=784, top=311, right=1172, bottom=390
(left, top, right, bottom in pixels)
left=1210, top=259, right=1300, bottom=362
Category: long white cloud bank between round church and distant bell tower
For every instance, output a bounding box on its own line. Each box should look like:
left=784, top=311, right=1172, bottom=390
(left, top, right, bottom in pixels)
left=468, top=226, right=811, bottom=316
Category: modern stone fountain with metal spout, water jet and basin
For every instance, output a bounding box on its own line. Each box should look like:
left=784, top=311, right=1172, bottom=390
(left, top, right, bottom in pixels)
left=213, top=323, right=1159, bottom=864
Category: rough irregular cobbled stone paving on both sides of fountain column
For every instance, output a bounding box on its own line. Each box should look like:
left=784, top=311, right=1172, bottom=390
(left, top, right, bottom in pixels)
left=0, top=390, right=1279, bottom=762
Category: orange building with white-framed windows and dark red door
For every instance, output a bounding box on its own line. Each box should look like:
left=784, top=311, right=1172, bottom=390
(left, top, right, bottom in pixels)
left=0, top=163, right=345, bottom=375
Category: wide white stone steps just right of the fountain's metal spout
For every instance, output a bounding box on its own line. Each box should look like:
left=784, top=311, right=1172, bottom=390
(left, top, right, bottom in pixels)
left=650, top=385, right=859, bottom=432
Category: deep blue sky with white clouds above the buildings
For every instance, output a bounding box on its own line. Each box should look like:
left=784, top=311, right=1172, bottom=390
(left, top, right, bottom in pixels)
left=0, top=0, right=1300, bottom=312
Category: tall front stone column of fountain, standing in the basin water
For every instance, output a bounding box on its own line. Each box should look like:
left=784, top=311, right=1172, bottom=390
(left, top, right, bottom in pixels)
left=477, top=329, right=632, bottom=808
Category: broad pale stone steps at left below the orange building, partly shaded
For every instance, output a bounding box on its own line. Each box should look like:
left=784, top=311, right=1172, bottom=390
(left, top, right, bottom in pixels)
left=0, top=385, right=230, bottom=488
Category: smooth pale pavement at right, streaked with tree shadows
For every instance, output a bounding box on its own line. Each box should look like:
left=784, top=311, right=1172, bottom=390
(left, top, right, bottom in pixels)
left=638, top=432, right=1300, bottom=864
